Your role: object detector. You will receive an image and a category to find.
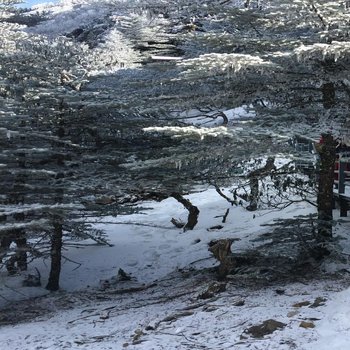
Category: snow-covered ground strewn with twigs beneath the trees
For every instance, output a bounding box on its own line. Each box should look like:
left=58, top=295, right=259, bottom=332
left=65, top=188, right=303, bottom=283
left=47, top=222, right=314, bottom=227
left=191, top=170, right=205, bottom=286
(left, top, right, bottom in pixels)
left=0, top=190, right=350, bottom=350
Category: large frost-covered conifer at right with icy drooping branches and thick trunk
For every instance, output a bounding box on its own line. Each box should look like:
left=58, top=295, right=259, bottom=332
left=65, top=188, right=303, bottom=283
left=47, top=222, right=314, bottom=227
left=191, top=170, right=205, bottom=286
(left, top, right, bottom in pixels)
left=100, top=0, right=349, bottom=241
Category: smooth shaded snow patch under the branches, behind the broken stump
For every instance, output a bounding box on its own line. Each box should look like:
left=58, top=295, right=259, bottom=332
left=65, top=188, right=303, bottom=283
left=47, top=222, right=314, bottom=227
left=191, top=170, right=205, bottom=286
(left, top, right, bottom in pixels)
left=0, top=189, right=318, bottom=291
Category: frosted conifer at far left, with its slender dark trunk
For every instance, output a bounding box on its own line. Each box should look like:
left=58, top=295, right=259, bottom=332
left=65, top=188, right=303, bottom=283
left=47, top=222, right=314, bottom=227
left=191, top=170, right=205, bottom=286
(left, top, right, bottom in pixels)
left=0, top=1, right=117, bottom=290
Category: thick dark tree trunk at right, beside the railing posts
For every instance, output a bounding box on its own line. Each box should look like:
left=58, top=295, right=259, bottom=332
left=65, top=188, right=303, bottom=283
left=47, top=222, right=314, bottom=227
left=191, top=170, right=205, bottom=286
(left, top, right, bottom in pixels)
left=317, top=134, right=336, bottom=242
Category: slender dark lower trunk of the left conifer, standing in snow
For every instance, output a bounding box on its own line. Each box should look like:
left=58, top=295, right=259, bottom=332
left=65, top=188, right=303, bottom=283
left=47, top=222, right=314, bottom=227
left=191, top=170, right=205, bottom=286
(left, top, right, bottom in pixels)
left=46, top=219, right=63, bottom=291
